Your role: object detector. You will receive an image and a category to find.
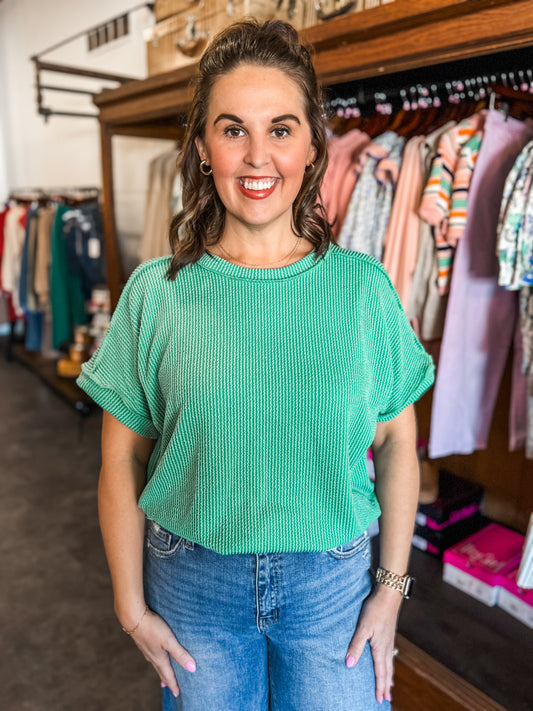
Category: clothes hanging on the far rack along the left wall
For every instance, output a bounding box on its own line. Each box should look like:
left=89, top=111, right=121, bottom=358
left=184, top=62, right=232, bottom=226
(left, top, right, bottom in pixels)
left=0, top=189, right=106, bottom=355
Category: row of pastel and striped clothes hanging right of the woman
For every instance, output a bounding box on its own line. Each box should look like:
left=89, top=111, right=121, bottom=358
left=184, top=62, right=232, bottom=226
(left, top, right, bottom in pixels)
left=323, top=85, right=533, bottom=458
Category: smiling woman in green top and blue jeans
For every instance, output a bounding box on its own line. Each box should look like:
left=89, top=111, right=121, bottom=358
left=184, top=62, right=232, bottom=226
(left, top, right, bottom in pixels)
left=79, top=22, right=433, bottom=711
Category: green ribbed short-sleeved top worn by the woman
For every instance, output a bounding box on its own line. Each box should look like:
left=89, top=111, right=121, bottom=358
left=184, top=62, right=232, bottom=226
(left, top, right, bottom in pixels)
left=78, top=245, right=433, bottom=553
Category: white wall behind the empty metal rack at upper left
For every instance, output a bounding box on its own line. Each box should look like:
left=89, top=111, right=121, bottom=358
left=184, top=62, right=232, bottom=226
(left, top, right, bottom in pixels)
left=0, top=0, right=174, bottom=272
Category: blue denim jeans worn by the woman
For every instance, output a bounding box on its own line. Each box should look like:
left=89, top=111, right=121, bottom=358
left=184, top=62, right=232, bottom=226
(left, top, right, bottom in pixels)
left=144, top=521, right=390, bottom=711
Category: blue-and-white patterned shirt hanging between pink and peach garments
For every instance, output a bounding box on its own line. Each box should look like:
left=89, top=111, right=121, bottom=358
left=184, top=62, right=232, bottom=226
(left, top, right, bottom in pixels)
left=339, top=131, right=405, bottom=260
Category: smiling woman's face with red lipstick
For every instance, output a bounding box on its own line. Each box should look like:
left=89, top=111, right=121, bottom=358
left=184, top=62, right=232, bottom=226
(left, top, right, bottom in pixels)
left=196, top=64, right=316, bottom=236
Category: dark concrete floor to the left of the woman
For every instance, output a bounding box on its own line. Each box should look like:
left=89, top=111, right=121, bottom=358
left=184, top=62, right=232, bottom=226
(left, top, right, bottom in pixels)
left=0, top=354, right=161, bottom=711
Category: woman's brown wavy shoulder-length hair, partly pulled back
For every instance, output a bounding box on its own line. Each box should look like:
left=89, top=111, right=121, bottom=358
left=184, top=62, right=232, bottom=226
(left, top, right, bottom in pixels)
left=167, top=20, right=333, bottom=279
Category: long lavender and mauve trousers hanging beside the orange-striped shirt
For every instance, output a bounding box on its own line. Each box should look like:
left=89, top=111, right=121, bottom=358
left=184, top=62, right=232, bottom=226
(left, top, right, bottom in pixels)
left=429, top=111, right=533, bottom=458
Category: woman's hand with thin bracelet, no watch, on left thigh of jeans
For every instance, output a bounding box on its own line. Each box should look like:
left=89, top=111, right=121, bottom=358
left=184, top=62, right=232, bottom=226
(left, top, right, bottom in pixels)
left=124, top=610, right=196, bottom=696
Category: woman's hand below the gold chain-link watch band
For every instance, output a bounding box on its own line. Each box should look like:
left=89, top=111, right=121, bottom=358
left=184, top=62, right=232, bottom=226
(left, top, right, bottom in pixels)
left=346, top=585, right=402, bottom=703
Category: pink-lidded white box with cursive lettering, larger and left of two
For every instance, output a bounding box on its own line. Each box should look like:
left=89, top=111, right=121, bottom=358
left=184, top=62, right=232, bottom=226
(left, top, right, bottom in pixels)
left=443, top=523, right=525, bottom=605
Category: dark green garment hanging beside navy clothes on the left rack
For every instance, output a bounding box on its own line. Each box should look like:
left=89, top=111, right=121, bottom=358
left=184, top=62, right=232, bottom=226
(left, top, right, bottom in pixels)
left=50, top=205, right=87, bottom=348
